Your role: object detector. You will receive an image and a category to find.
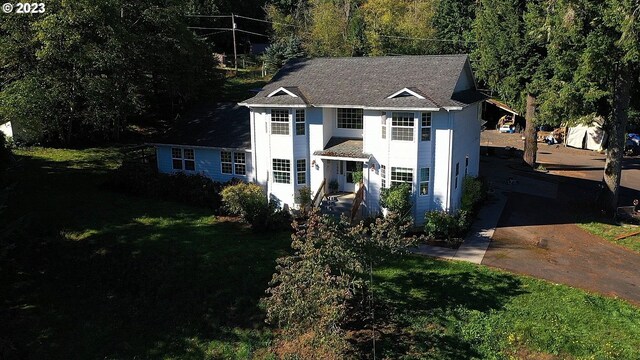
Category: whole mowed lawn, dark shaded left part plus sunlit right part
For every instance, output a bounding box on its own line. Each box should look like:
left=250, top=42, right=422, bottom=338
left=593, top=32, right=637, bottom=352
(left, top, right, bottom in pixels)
left=0, top=148, right=640, bottom=359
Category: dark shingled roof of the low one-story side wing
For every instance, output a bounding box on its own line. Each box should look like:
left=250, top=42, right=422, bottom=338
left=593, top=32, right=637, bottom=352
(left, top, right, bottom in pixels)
left=156, top=103, right=251, bottom=149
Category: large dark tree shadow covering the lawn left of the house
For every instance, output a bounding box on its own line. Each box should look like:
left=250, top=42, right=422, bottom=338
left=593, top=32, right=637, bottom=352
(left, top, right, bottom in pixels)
left=0, top=153, right=290, bottom=359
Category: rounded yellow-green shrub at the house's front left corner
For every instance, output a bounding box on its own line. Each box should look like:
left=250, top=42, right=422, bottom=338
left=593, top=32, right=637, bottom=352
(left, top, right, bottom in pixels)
left=221, top=183, right=291, bottom=231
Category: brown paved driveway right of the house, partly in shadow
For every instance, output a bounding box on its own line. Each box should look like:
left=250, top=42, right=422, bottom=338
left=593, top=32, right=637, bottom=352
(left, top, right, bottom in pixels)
left=481, top=136, right=640, bottom=306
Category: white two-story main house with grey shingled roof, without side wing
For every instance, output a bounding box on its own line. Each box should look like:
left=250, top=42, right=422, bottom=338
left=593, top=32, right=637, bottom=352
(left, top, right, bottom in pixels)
left=239, top=55, right=485, bottom=224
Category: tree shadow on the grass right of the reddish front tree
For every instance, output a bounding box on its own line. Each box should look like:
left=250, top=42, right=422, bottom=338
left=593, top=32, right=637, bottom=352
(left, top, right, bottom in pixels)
left=359, top=256, right=526, bottom=359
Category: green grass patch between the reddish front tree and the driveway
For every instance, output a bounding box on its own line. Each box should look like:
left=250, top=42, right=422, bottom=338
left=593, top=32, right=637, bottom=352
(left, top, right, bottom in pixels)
left=374, top=257, right=640, bottom=359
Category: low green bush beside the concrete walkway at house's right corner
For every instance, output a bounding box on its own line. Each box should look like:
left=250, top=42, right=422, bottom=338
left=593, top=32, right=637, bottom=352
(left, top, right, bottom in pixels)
left=424, top=210, right=470, bottom=242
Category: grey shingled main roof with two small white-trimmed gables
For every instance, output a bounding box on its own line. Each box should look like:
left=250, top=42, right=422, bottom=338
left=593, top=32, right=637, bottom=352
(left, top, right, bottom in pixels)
left=242, top=55, right=482, bottom=108
